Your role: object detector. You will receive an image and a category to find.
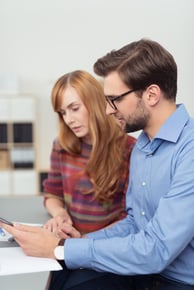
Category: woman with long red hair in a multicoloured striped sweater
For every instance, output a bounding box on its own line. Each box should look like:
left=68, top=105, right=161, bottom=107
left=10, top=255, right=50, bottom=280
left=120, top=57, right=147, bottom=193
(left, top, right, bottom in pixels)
left=43, top=71, right=135, bottom=237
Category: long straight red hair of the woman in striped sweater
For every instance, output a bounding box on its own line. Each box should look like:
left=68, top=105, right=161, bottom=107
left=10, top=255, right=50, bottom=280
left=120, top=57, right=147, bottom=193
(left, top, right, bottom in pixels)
left=52, top=71, right=127, bottom=201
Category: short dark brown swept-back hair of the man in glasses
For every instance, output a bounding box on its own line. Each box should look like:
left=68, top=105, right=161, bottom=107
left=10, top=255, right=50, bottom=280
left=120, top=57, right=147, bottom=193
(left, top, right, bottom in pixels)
left=94, top=39, right=177, bottom=100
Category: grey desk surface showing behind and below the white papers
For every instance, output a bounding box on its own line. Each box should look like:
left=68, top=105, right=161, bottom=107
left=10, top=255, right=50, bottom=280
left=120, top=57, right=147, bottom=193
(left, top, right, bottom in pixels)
left=0, top=196, right=49, bottom=290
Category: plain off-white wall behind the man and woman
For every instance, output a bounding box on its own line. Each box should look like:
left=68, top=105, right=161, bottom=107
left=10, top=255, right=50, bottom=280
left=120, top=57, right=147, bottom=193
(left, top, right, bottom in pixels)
left=0, top=0, right=194, bottom=168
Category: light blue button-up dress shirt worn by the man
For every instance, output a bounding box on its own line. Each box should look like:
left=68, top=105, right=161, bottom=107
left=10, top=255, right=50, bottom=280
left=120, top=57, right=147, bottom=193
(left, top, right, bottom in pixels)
left=64, top=105, right=194, bottom=284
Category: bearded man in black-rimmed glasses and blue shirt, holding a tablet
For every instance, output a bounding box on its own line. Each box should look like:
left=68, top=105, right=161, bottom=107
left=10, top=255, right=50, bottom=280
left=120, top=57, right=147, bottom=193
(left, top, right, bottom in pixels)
left=1, top=39, right=194, bottom=290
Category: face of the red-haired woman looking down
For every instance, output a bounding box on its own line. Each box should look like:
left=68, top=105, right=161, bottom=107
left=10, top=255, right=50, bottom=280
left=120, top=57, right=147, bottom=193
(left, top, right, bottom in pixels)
left=59, top=86, right=91, bottom=144
